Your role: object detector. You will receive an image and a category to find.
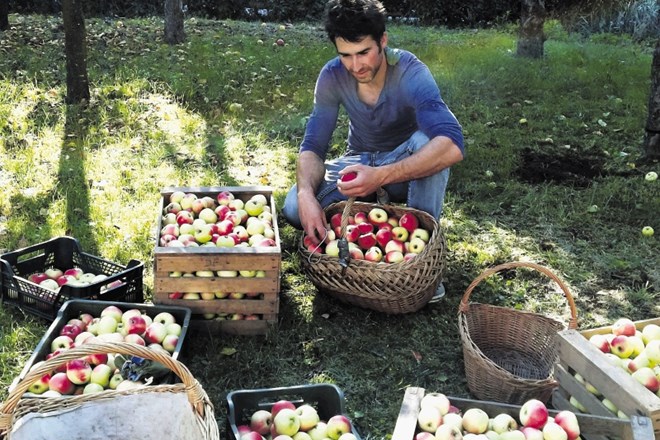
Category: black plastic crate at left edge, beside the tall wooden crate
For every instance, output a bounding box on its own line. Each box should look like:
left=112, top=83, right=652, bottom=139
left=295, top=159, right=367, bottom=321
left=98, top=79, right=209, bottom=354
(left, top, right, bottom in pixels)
left=0, top=237, right=144, bottom=320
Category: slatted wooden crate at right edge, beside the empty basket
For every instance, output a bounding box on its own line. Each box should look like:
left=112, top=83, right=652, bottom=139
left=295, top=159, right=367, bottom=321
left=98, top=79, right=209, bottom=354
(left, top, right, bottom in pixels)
left=552, top=318, right=660, bottom=440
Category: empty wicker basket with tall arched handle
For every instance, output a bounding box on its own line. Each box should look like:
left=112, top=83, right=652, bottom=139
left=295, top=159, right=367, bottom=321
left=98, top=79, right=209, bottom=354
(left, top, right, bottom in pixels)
left=458, top=262, right=577, bottom=405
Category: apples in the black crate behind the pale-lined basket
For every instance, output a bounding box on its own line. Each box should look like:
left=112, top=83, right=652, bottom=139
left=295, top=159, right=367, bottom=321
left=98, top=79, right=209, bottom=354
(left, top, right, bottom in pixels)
left=28, top=305, right=181, bottom=397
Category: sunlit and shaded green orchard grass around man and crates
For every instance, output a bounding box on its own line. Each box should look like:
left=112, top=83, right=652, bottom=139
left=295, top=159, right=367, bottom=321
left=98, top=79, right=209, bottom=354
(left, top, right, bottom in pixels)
left=0, top=15, right=660, bottom=439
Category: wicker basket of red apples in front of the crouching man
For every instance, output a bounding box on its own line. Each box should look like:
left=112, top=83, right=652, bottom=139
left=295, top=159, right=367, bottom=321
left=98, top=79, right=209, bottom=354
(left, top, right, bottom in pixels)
left=299, top=198, right=446, bottom=314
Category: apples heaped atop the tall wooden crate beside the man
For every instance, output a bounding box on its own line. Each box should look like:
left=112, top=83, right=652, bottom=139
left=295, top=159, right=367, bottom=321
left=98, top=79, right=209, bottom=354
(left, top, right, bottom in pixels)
left=158, top=191, right=277, bottom=247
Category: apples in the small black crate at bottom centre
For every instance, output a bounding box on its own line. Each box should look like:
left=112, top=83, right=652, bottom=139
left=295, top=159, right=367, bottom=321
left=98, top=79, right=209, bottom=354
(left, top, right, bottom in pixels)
left=237, top=399, right=357, bottom=440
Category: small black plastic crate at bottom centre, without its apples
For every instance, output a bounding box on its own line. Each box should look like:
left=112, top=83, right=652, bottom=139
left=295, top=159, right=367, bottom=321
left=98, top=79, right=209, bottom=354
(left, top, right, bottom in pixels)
left=226, top=383, right=360, bottom=440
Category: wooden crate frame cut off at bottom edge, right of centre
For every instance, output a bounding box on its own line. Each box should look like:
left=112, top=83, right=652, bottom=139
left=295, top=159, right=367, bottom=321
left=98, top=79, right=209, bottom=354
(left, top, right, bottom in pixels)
left=392, top=387, right=653, bottom=440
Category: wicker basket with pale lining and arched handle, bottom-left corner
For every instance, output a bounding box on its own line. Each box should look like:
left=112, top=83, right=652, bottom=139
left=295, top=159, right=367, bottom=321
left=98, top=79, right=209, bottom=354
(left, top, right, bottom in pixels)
left=0, top=342, right=220, bottom=440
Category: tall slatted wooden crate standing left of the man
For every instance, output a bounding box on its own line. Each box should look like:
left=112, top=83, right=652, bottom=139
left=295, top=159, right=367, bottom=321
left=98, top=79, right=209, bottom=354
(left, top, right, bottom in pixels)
left=153, top=187, right=282, bottom=335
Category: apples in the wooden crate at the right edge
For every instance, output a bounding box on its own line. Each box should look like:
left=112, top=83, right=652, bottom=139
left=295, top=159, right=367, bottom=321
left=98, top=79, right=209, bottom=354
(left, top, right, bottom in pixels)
left=570, top=318, right=660, bottom=412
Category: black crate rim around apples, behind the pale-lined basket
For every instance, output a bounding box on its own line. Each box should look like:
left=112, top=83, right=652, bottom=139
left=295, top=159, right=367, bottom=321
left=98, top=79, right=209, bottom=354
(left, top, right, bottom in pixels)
left=10, top=299, right=191, bottom=390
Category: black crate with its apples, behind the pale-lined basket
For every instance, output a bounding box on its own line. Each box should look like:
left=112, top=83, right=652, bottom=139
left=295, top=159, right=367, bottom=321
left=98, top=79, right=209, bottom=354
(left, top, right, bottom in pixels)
left=19, top=300, right=190, bottom=396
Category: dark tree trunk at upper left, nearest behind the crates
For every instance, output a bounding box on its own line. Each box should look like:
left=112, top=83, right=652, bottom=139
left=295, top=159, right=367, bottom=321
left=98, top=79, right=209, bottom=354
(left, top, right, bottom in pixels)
left=62, top=0, right=89, bottom=104
